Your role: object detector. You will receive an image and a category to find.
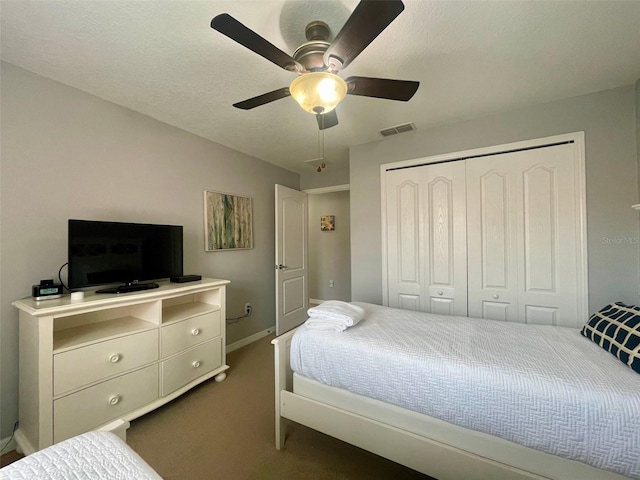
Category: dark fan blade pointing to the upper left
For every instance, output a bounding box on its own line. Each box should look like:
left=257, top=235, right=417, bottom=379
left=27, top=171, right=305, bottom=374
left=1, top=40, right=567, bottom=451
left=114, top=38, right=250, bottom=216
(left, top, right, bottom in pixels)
left=211, top=13, right=304, bottom=71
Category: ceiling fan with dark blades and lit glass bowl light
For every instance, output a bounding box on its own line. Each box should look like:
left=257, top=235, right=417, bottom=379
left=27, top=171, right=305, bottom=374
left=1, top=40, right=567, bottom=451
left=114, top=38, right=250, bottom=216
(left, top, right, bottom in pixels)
left=211, top=0, right=420, bottom=130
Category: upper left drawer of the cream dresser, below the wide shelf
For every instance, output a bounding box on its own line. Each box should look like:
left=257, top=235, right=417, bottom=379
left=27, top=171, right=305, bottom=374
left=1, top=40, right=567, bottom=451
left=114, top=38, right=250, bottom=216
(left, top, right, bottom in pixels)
left=53, top=330, right=158, bottom=396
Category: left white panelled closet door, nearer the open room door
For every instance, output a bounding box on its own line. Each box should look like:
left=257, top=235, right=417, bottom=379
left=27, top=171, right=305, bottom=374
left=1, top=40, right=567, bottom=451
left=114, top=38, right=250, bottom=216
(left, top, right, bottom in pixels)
left=385, top=162, right=467, bottom=315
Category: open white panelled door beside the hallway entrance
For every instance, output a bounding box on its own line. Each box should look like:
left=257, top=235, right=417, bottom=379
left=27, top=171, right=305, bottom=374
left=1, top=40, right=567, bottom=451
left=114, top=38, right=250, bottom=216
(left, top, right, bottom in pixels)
left=275, top=185, right=309, bottom=335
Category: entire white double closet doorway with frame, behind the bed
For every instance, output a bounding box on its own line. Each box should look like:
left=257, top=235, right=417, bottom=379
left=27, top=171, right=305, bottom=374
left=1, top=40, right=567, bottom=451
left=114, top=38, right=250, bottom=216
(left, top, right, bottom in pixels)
left=382, top=132, right=588, bottom=327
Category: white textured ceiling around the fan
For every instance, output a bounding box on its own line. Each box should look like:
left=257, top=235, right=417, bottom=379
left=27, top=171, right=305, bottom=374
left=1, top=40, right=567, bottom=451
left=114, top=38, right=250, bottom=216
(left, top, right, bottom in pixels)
left=0, top=0, right=640, bottom=173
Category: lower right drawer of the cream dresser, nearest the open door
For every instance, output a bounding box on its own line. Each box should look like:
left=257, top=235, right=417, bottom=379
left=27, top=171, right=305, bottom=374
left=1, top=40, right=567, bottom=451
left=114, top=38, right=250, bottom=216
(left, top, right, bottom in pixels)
left=161, top=338, right=222, bottom=396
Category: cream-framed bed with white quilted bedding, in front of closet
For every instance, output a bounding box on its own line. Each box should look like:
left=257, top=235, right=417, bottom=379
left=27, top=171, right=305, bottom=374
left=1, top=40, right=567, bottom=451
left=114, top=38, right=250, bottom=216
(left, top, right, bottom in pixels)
left=274, top=304, right=640, bottom=480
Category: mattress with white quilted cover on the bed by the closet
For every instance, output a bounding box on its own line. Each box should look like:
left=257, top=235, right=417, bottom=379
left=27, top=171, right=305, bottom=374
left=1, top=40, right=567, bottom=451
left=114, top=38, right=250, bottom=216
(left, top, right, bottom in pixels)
left=291, top=303, right=640, bottom=479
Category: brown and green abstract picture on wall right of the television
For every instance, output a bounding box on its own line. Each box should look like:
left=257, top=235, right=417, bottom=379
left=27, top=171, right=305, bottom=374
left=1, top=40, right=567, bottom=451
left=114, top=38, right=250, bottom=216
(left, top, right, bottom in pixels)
left=204, top=190, right=253, bottom=252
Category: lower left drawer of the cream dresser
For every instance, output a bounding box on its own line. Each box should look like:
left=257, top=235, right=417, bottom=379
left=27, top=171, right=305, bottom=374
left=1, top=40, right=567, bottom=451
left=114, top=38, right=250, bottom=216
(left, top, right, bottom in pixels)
left=53, top=364, right=158, bottom=443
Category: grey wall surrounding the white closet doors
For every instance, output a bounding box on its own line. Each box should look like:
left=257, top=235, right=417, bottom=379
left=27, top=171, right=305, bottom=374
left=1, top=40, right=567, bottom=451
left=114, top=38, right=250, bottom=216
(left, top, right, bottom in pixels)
left=350, top=85, right=640, bottom=314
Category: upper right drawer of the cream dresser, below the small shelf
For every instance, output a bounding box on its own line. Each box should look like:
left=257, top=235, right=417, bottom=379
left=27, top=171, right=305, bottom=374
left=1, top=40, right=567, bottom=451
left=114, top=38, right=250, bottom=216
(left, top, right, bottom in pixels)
left=161, top=310, right=220, bottom=358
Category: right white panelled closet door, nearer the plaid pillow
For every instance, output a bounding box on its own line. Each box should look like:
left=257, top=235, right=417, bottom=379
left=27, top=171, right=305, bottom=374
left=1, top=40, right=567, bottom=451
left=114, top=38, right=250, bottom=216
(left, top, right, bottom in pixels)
left=466, top=144, right=579, bottom=327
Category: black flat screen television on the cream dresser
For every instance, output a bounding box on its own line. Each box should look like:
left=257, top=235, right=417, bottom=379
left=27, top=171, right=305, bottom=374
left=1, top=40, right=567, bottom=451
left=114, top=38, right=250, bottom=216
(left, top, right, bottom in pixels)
left=68, top=220, right=182, bottom=293
